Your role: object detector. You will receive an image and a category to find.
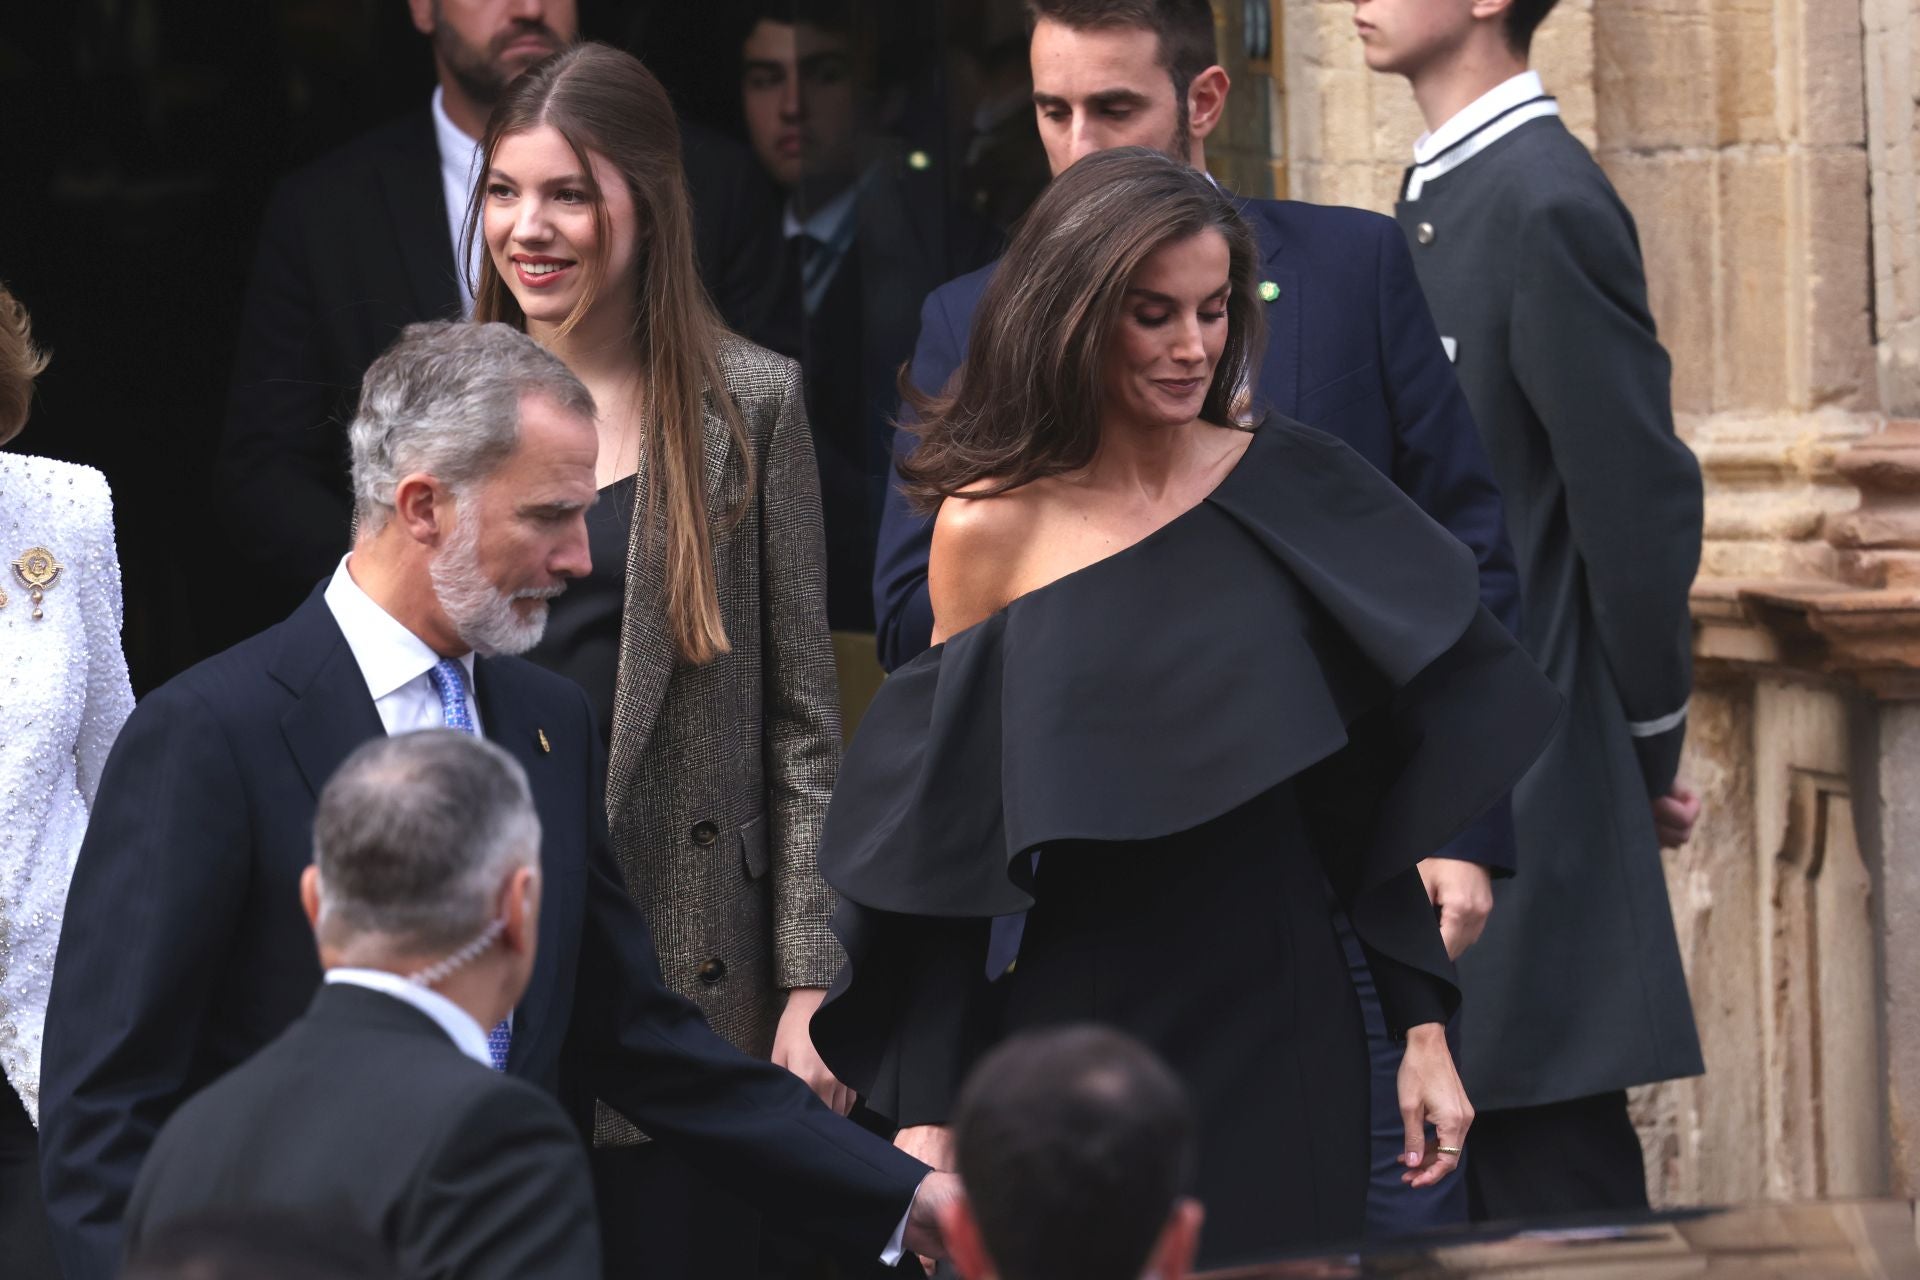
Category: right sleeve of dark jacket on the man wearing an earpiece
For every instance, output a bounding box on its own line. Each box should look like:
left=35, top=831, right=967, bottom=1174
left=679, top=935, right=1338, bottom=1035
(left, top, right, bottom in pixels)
left=399, top=1086, right=601, bottom=1280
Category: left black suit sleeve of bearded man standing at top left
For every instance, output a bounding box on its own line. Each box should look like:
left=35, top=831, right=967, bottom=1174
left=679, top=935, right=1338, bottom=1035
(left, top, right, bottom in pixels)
left=215, top=173, right=357, bottom=593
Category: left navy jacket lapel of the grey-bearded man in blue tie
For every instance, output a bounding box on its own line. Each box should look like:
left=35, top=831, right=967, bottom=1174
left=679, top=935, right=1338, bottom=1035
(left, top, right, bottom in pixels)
left=269, top=591, right=386, bottom=796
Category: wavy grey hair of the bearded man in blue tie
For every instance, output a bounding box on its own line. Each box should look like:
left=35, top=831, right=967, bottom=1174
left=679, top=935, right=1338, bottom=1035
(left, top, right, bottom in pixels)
left=348, top=320, right=595, bottom=533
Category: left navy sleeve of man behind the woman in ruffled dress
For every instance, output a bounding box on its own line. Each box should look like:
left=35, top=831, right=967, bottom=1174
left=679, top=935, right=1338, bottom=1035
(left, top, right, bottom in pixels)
left=874, top=288, right=966, bottom=672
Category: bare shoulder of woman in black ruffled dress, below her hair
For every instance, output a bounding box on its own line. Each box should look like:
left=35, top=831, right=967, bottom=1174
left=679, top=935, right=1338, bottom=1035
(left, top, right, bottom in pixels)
left=927, top=486, right=1043, bottom=643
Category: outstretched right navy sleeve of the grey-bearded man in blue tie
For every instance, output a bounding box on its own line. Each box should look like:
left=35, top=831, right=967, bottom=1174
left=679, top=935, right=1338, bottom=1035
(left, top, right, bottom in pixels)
left=566, top=697, right=927, bottom=1263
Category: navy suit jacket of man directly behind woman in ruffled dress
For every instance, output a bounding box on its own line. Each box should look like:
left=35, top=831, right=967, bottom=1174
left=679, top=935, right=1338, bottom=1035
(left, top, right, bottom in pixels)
left=874, top=200, right=1521, bottom=871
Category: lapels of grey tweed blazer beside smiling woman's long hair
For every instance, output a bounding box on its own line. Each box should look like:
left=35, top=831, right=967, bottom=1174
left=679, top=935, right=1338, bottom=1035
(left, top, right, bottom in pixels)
left=607, top=379, right=737, bottom=827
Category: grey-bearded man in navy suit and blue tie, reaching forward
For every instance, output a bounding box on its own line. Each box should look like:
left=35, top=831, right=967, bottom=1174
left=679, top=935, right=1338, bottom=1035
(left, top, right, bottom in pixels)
left=40, top=322, right=956, bottom=1280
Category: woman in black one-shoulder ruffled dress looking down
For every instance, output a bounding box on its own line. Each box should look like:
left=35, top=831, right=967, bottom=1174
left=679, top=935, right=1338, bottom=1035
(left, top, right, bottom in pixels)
left=814, top=150, right=1557, bottom=1265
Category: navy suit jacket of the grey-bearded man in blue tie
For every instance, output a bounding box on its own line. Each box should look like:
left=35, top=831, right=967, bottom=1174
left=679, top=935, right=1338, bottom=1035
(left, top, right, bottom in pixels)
left=40, top=591, right=925, bottom=1280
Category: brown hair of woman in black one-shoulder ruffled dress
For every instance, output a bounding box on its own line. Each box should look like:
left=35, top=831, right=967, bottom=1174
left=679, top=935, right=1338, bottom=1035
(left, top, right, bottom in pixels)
left=899, top=146, right=1265, bottom=510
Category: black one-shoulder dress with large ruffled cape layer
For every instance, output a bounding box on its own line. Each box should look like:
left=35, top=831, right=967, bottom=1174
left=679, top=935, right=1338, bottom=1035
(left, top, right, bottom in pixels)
left=812, top=416, right=1559, bottom=1265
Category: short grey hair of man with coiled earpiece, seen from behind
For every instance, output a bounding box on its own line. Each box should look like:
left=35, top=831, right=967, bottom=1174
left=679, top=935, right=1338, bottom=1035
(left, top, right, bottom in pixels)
left=313, top=729, right=540, bottom=956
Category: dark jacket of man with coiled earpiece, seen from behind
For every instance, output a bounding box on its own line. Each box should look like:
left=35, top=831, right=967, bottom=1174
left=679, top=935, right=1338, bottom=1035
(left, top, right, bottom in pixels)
left=127, top=984, right=599, bottom=1280
